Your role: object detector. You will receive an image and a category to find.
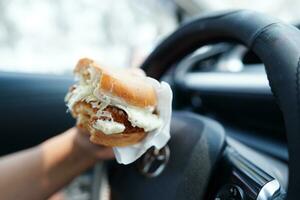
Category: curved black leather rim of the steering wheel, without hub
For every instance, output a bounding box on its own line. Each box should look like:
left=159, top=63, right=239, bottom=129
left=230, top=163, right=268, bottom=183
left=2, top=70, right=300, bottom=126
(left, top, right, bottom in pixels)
left=142, top=10, right=300, bottom=199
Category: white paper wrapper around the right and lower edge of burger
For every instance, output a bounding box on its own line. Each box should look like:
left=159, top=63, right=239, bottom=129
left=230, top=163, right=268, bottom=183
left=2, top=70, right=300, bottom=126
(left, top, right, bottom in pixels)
left=113, top=77, right=172, bottom=165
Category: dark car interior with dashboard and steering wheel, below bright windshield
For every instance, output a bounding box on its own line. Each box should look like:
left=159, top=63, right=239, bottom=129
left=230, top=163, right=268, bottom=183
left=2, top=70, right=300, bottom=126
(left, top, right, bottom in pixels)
left=0, top=1, right=300, bottom=200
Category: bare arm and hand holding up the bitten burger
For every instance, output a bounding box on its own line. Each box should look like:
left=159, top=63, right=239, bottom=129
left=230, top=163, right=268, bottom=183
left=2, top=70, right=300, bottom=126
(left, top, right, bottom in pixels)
left=0, top=128, right=113, bottom=200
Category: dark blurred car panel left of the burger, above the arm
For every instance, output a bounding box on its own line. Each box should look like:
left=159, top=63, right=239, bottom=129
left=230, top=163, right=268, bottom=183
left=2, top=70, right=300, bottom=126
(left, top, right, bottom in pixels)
left=0, top=72, right=74, bottom=155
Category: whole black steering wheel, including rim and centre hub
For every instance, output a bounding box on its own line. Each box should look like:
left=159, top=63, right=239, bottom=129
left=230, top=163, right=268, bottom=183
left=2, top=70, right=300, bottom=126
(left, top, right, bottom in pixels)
left=103, top=10, right=300, bottom=200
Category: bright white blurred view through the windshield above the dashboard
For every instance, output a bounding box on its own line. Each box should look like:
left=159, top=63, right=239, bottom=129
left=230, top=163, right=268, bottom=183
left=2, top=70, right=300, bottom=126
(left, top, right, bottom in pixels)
left=0, top=0, right=300, bottom=74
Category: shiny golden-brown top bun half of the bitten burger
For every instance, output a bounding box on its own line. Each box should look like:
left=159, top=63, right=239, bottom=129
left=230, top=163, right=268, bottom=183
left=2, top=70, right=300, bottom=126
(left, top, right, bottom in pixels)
left=74, top=58, right=157, bottom=108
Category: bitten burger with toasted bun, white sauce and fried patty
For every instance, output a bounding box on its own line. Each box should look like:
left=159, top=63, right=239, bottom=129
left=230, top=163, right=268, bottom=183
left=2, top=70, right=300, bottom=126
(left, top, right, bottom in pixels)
left=65, top=58, right=162, bottom=147
